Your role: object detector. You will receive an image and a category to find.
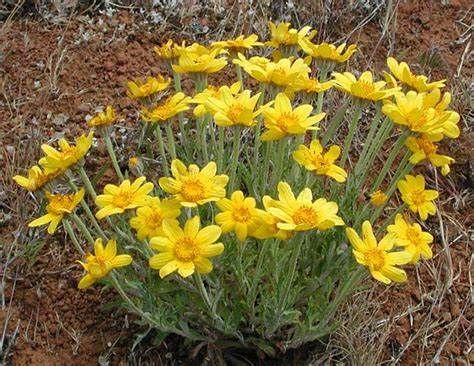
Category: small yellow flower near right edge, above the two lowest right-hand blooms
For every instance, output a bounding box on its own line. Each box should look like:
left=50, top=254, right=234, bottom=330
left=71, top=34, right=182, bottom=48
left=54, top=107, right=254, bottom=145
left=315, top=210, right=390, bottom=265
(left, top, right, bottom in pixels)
left=397, top=175, right=439, bottom=221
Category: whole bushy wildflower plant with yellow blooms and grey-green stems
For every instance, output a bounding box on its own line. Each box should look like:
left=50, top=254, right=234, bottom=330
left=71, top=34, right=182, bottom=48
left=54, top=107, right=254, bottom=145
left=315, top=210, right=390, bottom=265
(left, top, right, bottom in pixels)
left=14, top=23, right=459, bottom=354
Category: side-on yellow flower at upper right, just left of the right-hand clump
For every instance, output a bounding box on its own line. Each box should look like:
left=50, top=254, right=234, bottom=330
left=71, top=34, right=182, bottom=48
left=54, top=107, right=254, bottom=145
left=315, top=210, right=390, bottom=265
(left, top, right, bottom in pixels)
left=332, top=71, right=400, bottom=101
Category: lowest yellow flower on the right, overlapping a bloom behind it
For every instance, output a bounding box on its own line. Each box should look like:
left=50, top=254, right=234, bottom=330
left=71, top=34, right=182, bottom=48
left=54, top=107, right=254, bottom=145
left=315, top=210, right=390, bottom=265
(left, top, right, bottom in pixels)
left=346, top=221, right=412, bottom=285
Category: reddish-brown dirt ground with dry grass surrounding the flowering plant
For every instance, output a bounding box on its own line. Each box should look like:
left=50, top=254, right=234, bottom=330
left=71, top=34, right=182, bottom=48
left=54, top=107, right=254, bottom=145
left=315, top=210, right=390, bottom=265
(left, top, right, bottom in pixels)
left=0, top=0, right=474, bottom=365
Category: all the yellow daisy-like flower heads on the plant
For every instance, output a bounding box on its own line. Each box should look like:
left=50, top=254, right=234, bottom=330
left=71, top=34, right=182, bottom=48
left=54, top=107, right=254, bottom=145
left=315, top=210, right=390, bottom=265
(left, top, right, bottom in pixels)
left=14, top=23, right=460, bottom=288
